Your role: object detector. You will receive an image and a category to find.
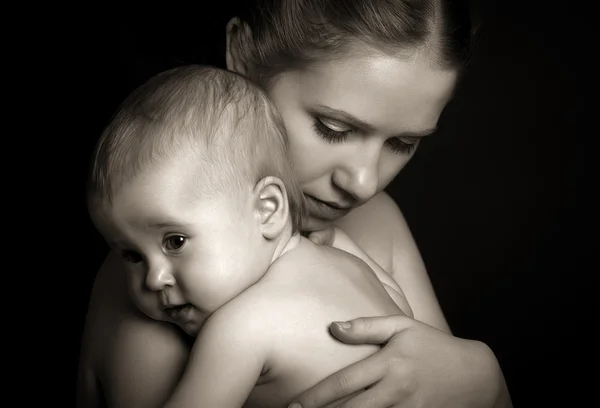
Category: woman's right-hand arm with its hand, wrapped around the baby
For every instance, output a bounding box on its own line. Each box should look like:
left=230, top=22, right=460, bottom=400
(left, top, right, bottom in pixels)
left=290, top=194, right=512, bottom=408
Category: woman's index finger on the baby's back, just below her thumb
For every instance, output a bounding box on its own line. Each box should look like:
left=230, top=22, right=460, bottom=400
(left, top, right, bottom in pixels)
left=290, top=354, right=385, bottom=408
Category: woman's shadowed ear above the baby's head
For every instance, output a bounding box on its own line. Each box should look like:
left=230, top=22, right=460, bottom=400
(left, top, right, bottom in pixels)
left=225, top=17, right=253, bottom=76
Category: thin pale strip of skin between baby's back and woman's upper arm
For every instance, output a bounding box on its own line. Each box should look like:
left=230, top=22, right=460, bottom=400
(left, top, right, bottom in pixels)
left=309, top=226, right=413, bottom=317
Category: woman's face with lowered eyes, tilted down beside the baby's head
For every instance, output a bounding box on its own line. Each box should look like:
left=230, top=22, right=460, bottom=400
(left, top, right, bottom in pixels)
left=268, top=48, right=456, bottom=230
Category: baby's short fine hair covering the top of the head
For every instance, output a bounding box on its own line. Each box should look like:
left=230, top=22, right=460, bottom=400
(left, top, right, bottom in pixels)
left=88, top=65, right=305, bottom=232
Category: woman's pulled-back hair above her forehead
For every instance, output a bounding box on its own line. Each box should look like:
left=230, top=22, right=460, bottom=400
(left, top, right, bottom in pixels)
left=234, top=0, right=471, bottom=86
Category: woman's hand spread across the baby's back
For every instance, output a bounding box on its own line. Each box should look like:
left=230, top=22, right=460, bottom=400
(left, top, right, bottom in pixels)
left=290, top=316, right=512, bottom=408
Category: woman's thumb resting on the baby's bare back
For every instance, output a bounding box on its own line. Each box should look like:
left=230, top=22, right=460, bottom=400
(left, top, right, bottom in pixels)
left=330, top=315, right=415, bottom=344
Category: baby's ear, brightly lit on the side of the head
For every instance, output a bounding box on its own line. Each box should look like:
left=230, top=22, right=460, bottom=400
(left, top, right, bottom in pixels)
left=254, top=176, right=290, bottom=239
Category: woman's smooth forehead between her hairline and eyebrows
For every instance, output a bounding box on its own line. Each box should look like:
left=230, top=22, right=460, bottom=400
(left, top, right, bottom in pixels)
left=275, top=52, right=457, bottom=132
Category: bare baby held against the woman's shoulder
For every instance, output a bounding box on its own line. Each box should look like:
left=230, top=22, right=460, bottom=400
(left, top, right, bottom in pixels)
left=88, top=66, right=410, bottom=408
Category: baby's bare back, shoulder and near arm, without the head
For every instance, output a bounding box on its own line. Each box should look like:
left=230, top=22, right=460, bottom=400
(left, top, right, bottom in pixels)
left=161, top=236, right=403, bottom=408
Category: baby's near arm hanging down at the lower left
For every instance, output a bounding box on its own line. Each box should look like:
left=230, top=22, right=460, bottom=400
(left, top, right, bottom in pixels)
left=165, top=299, right=267, bottom=408
